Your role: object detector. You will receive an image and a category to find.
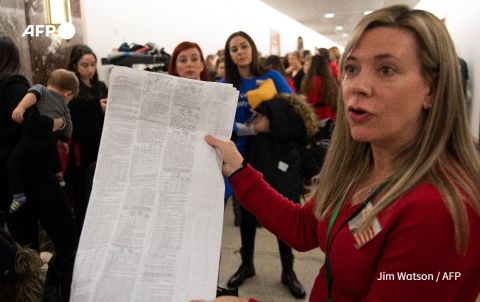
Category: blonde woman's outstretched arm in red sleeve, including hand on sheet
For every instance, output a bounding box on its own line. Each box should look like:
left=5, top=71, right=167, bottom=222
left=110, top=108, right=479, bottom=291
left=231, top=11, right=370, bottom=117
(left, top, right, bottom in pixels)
left=205, top=135, right=319, bottom=251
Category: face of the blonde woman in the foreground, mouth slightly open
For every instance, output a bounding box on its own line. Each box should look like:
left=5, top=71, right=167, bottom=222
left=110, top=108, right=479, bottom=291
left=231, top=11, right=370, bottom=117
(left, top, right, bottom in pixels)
left=342, top=27, right=433, bottom=150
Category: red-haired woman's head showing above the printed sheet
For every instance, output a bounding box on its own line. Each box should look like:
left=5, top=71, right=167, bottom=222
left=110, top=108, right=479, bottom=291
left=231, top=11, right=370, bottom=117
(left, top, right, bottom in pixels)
left=168, top=41, right=211, bottom=82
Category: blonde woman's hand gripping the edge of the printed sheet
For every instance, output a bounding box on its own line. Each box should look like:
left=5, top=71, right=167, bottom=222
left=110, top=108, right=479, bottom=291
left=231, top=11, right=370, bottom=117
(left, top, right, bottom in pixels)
left=205, top=134, right=243, bottom=177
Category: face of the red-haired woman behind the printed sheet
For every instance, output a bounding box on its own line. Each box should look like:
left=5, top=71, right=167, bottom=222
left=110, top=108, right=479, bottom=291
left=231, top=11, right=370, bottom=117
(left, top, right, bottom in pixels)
left=175, top=48, right=205, bottom=80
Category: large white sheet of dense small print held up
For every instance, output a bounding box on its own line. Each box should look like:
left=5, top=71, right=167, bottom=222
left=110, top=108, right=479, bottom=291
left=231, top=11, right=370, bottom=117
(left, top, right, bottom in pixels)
left=71, top=66, right=238, bottom=302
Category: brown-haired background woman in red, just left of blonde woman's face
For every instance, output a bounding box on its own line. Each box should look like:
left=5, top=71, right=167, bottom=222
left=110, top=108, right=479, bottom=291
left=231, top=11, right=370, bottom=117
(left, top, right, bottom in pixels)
left=301, top=55, right=338, bottom=121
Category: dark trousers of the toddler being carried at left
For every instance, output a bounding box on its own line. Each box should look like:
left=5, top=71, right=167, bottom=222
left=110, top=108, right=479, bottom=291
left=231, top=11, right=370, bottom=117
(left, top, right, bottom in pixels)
left=7, top=135, right=62, bottom=194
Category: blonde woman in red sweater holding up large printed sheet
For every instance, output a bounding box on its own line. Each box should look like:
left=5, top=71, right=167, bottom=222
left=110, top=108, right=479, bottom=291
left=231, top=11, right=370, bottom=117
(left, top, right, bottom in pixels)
left=194, top=5, right=480, bottom=302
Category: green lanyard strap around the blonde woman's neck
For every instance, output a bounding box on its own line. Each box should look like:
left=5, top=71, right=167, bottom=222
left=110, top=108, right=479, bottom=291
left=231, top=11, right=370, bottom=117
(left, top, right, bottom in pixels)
left=325, top=179, right=390, bottom=302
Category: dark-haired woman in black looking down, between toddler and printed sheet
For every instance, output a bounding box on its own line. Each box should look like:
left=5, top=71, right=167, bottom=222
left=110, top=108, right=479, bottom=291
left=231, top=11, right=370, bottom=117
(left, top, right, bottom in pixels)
left=65, top=44, right=107, bottom=234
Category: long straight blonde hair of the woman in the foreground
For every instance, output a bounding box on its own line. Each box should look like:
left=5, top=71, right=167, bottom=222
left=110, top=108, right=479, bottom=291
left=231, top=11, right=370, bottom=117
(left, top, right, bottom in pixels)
left=314, top=5, right=480, bottom=253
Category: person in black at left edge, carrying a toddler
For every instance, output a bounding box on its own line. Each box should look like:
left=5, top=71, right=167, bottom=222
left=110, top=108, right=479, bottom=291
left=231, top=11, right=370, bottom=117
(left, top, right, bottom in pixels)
left=0, top=37, right=78, bottom=301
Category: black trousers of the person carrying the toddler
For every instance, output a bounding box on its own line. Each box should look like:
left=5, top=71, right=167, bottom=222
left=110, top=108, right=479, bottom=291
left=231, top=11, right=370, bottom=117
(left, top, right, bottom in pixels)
left=0, top=154, right=78, bottom=278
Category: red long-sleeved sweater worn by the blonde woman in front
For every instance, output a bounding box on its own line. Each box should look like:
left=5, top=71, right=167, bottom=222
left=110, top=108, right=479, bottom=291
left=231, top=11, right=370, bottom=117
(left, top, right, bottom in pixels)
left=229, top=166, right=480, bottom=302
